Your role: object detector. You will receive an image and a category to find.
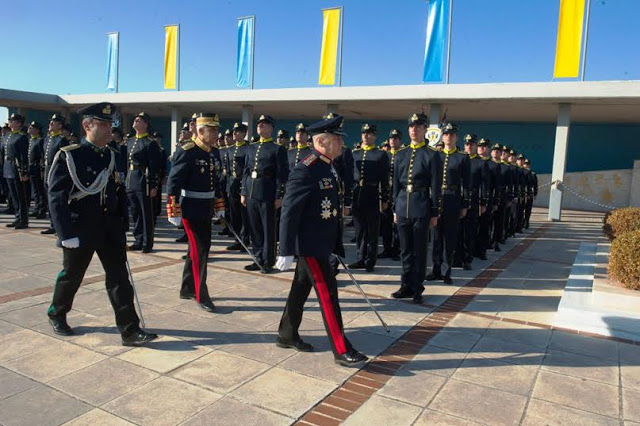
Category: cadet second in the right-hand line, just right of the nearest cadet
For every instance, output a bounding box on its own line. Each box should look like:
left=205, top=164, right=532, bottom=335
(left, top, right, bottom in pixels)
left=427, top=123, right=471, bottom=284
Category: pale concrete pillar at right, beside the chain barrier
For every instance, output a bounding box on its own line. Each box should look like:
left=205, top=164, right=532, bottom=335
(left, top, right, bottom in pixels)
left=549, top=104, right=571, bottom=222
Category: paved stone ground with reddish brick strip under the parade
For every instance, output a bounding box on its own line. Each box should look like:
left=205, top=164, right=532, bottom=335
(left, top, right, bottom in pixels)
left=0, top=210, right=640, bottom=425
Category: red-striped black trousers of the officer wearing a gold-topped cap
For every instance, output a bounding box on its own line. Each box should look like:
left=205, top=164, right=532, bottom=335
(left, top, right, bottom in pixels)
left=180, top=218, right=211, bottom=302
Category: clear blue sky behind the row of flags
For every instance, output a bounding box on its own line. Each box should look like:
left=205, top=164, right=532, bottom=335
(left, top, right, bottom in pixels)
left=0, top=0, right=640, bottom=93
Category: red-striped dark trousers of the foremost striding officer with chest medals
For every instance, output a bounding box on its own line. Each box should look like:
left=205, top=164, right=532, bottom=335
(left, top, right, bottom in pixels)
left=278, top=256, right=352, bottom=355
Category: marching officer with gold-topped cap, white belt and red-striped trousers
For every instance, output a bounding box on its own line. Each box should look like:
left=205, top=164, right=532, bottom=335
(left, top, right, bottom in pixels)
left=167, top=114, right=224, bottom=312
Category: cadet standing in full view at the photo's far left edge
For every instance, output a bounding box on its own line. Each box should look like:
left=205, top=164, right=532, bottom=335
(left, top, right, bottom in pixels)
left=2, top=113, right=31, bottom=229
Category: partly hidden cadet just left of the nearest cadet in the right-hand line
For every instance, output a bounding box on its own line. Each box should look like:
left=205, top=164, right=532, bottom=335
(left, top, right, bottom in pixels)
left=378, top=129, right=402, bottom=260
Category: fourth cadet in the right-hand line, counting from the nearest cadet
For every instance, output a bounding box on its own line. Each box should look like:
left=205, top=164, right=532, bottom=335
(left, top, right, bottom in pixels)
left=476, top=138, right=502, bottom=260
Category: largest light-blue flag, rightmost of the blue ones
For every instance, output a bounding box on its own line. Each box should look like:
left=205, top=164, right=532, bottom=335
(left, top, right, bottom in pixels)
left=422, top=0, right=451, bottom=83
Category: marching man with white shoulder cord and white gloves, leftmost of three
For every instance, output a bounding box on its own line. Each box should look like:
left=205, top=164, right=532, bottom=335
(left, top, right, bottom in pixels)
left=47, top=102, right=158, bottom=346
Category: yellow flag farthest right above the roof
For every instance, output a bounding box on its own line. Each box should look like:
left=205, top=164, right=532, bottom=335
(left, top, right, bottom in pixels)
left=553, top=0, right=585, bottom=78
